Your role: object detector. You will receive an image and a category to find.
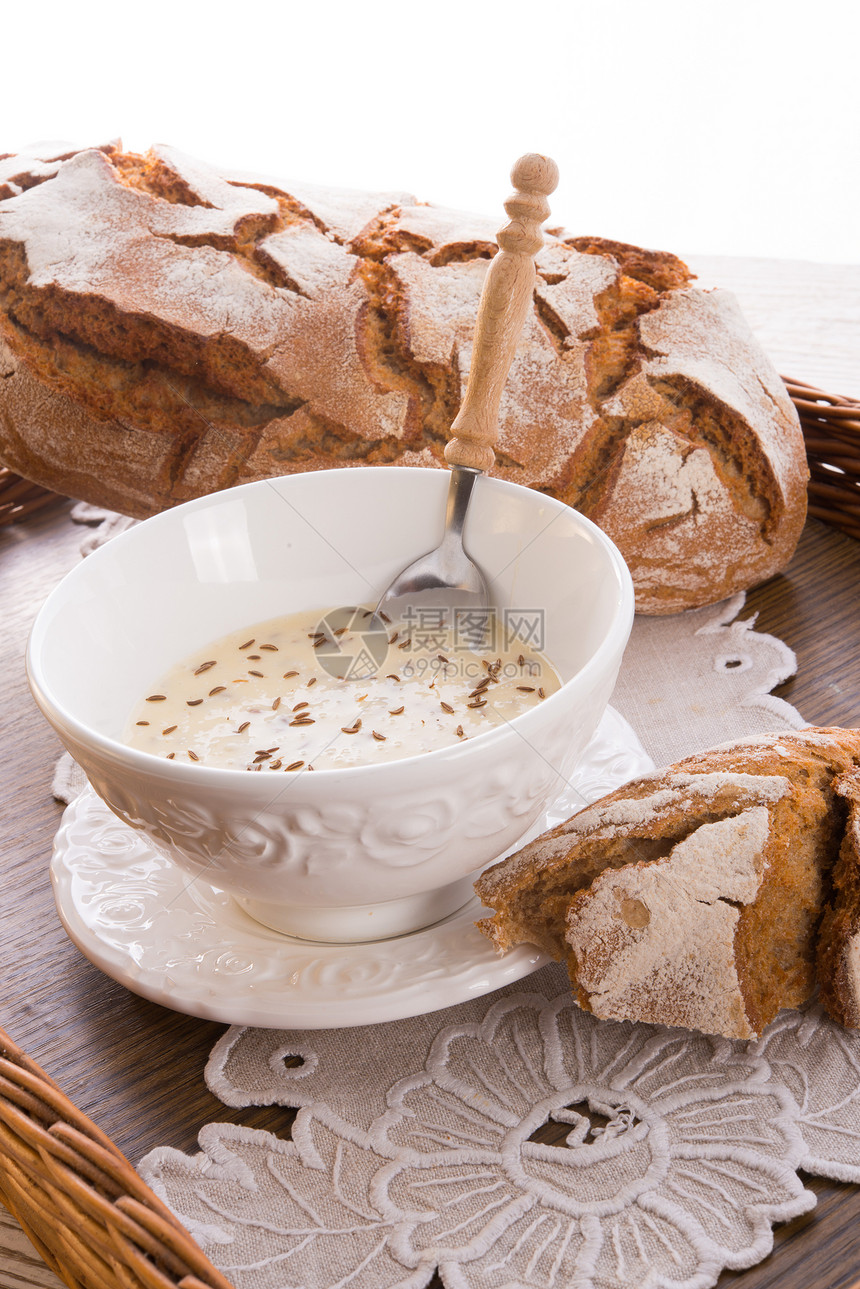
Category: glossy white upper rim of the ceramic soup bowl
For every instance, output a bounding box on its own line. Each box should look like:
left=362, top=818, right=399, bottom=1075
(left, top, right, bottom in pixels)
left=24, top=465, right=634, bottom=791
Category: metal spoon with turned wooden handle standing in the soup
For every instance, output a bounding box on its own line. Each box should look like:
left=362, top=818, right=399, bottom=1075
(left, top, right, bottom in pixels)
left=376, top=152, right=558, bottom=629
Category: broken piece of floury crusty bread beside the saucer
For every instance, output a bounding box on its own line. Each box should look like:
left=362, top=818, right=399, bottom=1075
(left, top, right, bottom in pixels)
left=476, top=728, right=860, bottom=1038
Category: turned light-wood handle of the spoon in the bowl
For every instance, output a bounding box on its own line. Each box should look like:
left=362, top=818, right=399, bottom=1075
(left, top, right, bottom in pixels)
left=445, top=152, right=558, bottom=470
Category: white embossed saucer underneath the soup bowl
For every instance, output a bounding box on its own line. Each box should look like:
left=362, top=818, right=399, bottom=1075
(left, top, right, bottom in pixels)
left=50, top=708, right=654, bottom=1030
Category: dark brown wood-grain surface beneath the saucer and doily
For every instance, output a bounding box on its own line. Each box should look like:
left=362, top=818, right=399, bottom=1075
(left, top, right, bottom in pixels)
left=0, top=253, right=860, bottom=1289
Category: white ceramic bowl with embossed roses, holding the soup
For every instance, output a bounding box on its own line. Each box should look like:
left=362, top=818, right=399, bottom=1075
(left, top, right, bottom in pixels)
left=27, top=467, right=633, bottom=941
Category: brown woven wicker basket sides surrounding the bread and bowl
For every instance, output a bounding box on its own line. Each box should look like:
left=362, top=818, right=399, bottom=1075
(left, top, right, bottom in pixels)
left=0, top=380, right=860, bottom=1289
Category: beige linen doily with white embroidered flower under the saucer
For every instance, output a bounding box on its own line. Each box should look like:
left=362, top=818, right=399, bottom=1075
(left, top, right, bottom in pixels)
left=129, top=597, right=860, bottom=1289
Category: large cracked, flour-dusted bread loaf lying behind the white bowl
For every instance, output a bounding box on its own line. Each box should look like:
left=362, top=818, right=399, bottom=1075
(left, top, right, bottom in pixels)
left=0, top=144, right=807, bottom=612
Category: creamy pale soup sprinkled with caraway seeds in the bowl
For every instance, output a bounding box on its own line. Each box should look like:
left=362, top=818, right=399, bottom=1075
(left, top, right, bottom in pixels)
left=125, top=608, right=561, bottom=773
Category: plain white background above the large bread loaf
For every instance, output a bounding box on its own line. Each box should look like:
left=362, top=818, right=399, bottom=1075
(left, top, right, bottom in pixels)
left=0, top=0, right=860, bottom=263
